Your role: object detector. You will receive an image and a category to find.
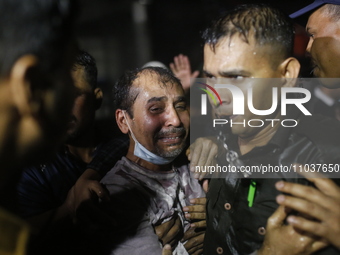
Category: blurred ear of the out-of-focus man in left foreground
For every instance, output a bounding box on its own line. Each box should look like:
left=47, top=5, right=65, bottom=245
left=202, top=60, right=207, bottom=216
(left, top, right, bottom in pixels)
left=9, top=55, right=41, bottom=115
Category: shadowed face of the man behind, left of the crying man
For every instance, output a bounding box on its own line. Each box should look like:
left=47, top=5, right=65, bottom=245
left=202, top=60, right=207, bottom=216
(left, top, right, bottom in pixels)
left=67, top=66, right=96, bottom=142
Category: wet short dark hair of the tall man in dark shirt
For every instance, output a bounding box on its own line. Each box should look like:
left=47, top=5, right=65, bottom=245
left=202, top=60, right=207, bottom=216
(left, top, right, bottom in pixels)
left=202, top=4, right=294, bottom=65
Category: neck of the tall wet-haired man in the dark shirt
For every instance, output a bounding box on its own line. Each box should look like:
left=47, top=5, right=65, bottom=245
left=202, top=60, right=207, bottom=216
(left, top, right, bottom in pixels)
left=238, top=116, right=281, bottom=155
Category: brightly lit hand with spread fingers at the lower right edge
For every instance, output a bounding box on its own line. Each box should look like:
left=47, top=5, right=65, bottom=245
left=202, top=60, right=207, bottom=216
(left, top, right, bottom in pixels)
left=276, top=172, right=340, bottom=249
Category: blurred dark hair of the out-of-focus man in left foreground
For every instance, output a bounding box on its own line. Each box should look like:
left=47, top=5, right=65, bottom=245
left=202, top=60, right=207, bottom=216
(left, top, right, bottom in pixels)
left=0, top=0, right=76, bottom=76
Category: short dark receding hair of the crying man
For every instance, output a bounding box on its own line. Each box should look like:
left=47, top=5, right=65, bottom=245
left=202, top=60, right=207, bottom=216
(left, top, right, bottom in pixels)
left=113, top=66, right=182, bottom=118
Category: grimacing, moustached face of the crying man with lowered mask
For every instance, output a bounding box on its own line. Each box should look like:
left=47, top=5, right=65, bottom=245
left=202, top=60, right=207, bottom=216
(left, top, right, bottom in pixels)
left=128, top=73, right=189, bottom=157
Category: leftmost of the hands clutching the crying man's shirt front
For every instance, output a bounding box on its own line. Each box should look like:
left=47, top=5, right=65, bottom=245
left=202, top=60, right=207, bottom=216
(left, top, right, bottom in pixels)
left=155, top=216, right=183, bottom=247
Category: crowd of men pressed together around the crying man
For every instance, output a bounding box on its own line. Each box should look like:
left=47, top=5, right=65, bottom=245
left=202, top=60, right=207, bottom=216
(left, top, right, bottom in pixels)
left=0, top=0, right=340, bottom=255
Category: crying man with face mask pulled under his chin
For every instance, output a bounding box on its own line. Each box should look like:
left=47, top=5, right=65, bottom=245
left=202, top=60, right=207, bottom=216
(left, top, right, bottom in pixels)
left=101, top=67, right=205, bottom=255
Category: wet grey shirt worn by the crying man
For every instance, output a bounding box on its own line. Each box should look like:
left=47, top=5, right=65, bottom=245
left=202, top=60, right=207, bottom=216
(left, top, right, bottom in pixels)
left=101, top=157, right=205, bottom=255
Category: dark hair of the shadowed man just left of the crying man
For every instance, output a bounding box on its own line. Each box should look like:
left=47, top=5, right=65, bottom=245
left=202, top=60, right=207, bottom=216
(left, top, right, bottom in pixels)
left=72, top=50, right=98, bottom=90
